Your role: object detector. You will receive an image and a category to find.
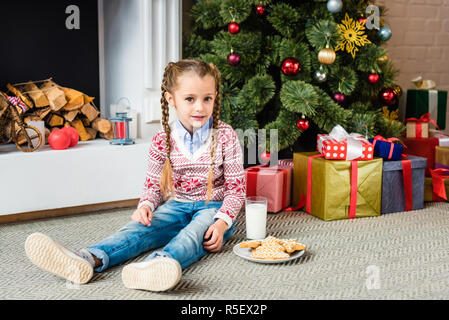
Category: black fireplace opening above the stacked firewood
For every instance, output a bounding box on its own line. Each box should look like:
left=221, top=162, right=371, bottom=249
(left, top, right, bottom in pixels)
left=0, top=0, right=100, bottom=106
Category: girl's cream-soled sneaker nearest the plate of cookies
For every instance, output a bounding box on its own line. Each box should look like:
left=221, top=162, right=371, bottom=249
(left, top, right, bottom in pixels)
left=122, top=257, right=182, bottom=291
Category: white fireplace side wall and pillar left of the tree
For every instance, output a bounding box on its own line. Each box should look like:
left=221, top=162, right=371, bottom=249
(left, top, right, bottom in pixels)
left=100, top=0, right=182, bottom=139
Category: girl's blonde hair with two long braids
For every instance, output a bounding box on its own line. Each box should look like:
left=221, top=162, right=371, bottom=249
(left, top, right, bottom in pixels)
left=159, top=59, right=221, bottom=202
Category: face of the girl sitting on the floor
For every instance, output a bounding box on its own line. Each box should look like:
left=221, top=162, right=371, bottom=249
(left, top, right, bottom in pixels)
left=165, top=72, right=217, bottom=134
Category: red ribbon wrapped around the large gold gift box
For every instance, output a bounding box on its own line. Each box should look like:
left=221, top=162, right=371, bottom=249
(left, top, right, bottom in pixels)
left=284, top=154, right=358, bottom=219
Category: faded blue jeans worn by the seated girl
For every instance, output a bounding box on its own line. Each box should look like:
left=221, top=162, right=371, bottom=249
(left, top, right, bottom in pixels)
left=87, top=201, right=234, bottom=272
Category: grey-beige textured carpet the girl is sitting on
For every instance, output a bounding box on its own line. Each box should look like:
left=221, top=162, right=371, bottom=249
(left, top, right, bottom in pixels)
left=0, top=203, right=449, bottom=300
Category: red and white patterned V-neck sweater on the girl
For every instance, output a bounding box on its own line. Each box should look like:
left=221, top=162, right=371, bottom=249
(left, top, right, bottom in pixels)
left=138, top=121, right=246, bottom=227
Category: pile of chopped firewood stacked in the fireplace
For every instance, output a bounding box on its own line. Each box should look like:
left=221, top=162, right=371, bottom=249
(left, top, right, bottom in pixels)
left=7, top=79, right=114, bottom=141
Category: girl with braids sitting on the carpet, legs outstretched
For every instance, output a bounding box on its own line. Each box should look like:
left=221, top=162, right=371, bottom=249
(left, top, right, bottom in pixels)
left=25, top=60, right=246, bottom=291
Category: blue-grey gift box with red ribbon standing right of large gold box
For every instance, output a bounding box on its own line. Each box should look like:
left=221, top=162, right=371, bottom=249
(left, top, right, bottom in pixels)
left=381, top=156, right=427, bottom=213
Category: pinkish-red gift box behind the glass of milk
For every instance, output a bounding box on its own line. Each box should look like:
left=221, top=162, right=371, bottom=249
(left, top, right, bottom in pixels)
left=245, top=160, right=293, bottom=213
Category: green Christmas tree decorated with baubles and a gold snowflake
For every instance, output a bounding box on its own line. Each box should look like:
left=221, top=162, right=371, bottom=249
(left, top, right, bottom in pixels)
left=183, top=0, right=404, bottom=159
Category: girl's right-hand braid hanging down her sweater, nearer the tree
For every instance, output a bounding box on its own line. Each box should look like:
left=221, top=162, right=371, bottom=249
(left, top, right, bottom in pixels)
left=206, top=63, right=221, bottom=203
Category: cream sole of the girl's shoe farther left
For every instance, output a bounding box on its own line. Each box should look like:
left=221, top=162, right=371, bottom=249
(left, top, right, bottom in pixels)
left=25, top=233, right=94, bottom=284
